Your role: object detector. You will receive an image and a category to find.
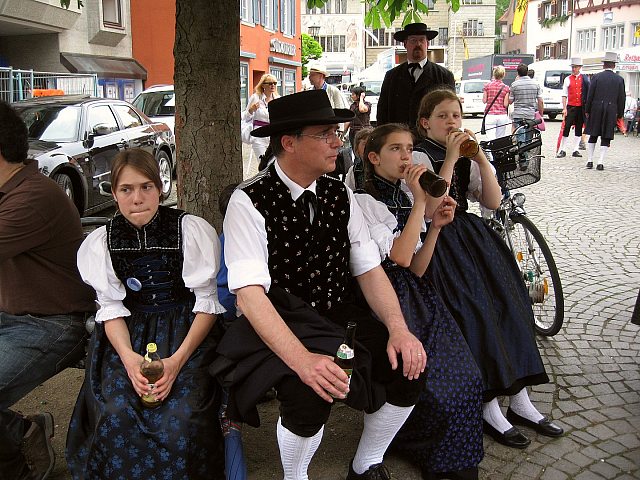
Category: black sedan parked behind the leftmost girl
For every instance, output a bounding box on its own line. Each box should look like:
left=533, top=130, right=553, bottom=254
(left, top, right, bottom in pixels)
left=13, top=95, right=176, bottom=215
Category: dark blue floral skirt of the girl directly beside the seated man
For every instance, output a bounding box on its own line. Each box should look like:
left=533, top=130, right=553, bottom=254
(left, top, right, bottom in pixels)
left=385, top=266, right=484, bottom=473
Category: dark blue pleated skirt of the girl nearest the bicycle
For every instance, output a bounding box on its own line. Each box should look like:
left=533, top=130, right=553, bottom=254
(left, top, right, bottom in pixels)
left=426, top=211, right=549, bottom=401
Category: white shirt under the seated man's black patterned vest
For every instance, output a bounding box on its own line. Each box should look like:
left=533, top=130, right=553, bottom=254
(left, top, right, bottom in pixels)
left=224, top=160, right=380, bottom=293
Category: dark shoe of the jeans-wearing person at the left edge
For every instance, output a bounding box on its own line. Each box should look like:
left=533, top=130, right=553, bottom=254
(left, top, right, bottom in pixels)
left=21, top=412, right=56, bottom=480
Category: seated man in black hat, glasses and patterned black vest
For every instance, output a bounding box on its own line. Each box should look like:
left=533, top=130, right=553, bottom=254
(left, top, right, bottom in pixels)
left=218, top=90, right=426, bottom=480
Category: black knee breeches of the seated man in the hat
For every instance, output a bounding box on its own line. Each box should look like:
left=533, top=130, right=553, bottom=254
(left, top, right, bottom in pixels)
left=276, top=304, right=424, bottom=437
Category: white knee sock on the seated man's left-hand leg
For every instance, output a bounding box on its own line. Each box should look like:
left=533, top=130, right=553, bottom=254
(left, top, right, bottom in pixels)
left=277, top=418, right=324, bottom=480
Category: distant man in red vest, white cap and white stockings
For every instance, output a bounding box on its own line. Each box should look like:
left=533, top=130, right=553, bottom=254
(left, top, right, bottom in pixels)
left=557, top=57, right=590, bottom=158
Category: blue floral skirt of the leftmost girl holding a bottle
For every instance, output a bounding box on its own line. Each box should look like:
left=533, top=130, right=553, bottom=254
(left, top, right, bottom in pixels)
left=66, top=304, right=224, bottom=480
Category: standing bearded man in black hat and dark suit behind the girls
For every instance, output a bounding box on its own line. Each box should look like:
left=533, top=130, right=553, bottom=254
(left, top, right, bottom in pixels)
left=376, top=23, right=455, bottom=128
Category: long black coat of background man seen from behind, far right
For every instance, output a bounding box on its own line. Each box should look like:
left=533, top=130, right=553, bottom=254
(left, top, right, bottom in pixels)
left=584, top=70, right=625, bottom=139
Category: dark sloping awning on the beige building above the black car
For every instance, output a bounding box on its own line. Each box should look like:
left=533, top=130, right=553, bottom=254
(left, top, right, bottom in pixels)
left=60, top=53, right=147, bottom=80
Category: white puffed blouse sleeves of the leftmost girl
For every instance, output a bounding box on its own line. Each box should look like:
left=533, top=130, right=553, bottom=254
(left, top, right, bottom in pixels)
left=78, top=215, right=226, bottom=322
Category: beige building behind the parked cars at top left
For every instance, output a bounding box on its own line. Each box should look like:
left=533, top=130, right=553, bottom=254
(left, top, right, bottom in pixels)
left=0, top=0, right=147, bottom=100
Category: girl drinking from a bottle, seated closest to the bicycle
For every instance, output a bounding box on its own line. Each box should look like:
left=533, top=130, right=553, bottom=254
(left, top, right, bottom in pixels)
left=414, top=90, right=563, bottom=448
